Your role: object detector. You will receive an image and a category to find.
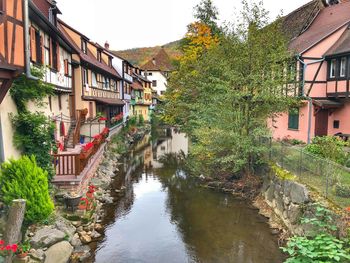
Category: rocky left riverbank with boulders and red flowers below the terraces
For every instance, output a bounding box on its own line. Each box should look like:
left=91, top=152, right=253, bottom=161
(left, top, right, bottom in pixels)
left=14, top=125, right=150, bottom=263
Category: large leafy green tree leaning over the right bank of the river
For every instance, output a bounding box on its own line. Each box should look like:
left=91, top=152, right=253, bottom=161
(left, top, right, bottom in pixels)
left=164, top=1, right=295, bottom=178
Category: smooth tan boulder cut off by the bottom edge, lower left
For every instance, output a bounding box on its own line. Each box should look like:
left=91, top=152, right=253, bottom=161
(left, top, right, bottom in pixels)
left=45, top=241, right=73, bottom=263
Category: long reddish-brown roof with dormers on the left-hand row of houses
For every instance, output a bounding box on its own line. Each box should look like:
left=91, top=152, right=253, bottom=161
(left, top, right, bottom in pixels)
left=57, top=20, right=121, bottom=79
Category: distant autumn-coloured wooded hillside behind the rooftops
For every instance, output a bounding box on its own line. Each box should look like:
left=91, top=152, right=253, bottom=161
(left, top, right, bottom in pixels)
left=113, top=40, right=181, bottom=66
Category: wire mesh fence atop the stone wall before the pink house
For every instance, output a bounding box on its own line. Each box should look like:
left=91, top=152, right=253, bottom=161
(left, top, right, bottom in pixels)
left=269, top=141, right=350, bottom=207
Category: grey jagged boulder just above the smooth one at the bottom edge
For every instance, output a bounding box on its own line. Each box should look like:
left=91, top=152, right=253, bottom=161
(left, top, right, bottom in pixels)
left=30, top=227, right=66, bottom=248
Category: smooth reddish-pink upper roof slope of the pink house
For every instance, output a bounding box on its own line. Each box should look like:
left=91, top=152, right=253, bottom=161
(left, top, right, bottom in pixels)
left=289, top=1, right=350, bottom=53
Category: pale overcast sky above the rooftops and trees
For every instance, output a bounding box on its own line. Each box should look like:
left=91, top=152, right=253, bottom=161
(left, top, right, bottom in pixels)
left=57, top=0, right=309, bottom=50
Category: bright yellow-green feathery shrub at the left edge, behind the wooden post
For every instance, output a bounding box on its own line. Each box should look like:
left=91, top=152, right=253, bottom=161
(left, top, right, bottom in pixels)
left=0, top=156, right=54, bottom=224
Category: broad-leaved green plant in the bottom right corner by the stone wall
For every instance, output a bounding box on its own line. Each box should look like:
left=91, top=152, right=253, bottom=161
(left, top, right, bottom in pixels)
left=281, top=205, right=350, bottom=263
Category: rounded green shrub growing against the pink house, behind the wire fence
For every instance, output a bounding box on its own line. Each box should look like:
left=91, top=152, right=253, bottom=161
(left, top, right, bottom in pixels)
left=305, top=136, right=348, bottom=164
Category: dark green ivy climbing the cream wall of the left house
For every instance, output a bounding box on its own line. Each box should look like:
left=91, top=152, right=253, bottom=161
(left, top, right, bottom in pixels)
left=10, top=67, right=55, bottom=179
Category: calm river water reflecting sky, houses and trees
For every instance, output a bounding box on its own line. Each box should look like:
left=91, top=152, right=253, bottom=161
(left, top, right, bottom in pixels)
left=95, top=130, right=283, bottom=263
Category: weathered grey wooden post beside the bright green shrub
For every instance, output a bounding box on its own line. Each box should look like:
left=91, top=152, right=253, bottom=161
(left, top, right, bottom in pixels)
left=5, top=199, right=26, bottom=263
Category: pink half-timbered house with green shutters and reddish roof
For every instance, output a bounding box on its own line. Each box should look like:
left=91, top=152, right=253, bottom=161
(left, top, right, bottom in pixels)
left=270, top=0, right=350, bottom=142
